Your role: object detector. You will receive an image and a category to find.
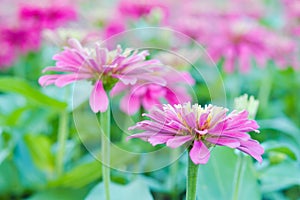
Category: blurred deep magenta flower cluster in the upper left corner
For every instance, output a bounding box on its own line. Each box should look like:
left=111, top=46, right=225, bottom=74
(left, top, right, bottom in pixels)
left=0, top=1, right=76, bottom=68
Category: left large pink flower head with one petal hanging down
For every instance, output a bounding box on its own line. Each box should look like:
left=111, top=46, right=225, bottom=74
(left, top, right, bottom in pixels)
left=39, top=39, right=165, bottom=112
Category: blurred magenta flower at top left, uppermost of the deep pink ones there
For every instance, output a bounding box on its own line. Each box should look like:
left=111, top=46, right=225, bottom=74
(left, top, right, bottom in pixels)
left=19, top=5, right=77, bottom=29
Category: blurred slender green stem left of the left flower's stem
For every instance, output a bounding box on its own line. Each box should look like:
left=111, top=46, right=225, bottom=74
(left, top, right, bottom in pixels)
left=56, top=110, right=69, bottom=176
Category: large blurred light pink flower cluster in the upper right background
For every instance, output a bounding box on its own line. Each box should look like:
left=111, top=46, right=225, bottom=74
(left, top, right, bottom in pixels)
left=170, top=0, right=297, bottom=73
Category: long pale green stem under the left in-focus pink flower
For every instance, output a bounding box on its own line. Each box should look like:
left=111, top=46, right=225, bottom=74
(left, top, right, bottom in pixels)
left=100, top=105, right=110, bottom=200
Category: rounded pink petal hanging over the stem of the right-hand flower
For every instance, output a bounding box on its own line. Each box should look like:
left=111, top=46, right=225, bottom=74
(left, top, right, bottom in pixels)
left=190, top=140, right=210, bottom=164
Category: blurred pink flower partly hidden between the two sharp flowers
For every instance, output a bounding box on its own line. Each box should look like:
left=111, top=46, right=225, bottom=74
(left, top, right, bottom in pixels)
left=111, top=68, right=195, bottom=115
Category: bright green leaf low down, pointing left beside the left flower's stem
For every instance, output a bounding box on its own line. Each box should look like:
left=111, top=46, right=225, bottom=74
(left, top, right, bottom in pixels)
left=49, top=160, right=102, bottom=188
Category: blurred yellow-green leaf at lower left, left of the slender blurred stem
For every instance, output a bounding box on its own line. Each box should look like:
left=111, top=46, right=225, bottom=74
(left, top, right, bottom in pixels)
left=24, top=134, right=55, bottom=173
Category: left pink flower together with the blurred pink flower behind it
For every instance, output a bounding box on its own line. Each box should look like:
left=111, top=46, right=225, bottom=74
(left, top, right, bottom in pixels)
left=39, top=39, right=193, bottom=114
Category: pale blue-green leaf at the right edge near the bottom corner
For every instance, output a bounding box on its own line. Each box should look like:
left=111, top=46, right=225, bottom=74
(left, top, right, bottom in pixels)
left=260, top=160, right=300, bottom=192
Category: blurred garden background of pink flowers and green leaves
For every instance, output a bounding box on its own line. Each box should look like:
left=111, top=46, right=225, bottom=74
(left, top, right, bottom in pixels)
left=0, top=0, right=300, bottom=200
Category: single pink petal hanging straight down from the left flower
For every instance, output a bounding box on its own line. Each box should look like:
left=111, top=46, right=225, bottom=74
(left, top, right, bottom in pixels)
left=90, top=80, right=109, bottom=113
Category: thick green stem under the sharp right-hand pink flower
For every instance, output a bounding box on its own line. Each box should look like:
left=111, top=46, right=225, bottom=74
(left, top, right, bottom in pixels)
left=186, top=150, right=199, bottom=200
